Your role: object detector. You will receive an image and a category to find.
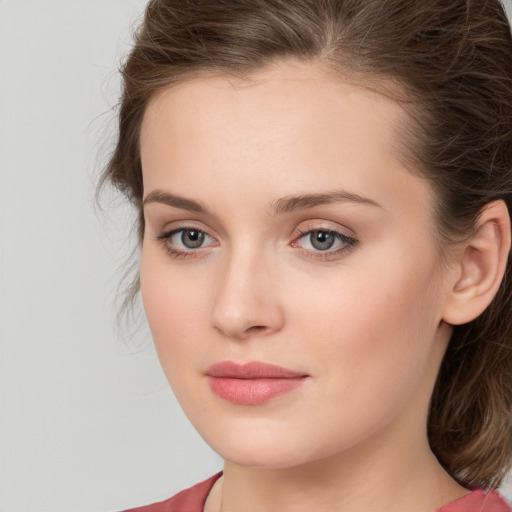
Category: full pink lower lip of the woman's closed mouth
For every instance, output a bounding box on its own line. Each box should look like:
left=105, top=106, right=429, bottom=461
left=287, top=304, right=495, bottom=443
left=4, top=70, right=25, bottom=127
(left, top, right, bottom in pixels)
left=208, top=377, right=306, bottom=405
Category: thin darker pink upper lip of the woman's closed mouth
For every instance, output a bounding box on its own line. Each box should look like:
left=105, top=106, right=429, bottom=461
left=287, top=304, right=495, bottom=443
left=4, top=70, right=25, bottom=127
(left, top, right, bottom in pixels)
left=206, top=361, right=307, bottom=379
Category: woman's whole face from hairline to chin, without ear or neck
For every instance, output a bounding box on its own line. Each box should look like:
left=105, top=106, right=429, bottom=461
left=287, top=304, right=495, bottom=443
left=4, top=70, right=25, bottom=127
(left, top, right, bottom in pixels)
left=141, top=64, right=456, bottom=467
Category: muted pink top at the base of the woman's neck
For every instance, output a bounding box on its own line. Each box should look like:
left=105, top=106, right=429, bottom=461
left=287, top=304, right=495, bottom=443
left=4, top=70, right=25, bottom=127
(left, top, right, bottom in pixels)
left=124, top=473, right=512, bottom=512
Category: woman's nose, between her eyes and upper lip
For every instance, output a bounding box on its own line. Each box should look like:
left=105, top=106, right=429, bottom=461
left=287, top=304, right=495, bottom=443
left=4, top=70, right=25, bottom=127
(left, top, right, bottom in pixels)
left=211, top=248, right=284, bottom=340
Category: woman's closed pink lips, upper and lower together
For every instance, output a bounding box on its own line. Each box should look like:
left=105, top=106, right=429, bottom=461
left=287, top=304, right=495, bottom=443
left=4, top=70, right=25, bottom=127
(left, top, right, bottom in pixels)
left=206, top=361, right=309, bottom=405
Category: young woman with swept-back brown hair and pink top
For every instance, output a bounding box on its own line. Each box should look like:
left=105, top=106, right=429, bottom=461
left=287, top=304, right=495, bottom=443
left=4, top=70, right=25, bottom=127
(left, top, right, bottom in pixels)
left=104, top=0, right=512, bottom=512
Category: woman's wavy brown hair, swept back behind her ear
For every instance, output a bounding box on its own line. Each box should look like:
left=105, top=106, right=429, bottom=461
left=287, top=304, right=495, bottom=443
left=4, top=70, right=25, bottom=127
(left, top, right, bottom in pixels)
left=100, top=0, right=512, bottom=488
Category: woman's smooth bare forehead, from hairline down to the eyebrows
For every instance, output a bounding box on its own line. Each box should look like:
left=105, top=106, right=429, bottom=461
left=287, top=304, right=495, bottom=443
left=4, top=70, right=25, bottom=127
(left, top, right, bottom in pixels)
left=141, top=59, right=432, bottom=222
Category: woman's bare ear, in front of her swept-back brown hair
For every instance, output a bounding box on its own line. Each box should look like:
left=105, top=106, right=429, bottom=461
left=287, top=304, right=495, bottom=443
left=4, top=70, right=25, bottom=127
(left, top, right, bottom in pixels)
left=443, top=200, right=511, bottom=325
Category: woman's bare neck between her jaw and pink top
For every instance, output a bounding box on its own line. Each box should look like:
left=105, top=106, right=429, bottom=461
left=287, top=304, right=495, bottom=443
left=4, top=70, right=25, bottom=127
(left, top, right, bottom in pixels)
left=211, top=424, right=468, bottom=512
